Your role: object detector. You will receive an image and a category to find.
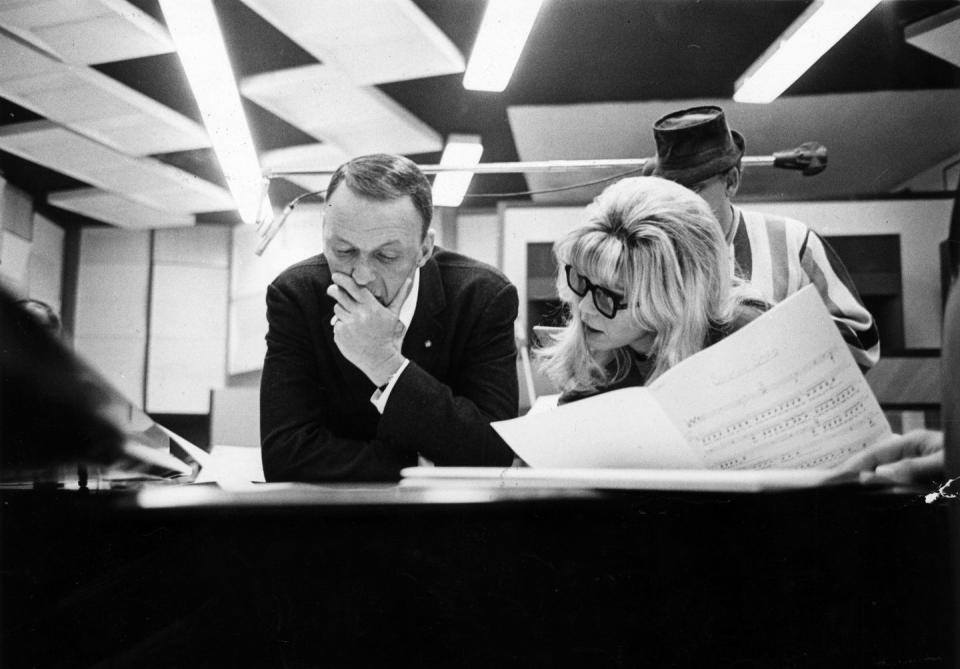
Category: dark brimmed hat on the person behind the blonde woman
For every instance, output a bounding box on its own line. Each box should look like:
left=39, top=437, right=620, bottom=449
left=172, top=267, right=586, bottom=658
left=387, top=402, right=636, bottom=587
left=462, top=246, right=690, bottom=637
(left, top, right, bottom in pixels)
left=643, top=105, right=744, bottom=186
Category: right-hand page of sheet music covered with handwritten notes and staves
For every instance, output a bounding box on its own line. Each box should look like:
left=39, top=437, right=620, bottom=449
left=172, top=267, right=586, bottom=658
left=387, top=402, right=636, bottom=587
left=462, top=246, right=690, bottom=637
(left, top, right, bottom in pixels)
left=650, top=286, right=890, bottom=469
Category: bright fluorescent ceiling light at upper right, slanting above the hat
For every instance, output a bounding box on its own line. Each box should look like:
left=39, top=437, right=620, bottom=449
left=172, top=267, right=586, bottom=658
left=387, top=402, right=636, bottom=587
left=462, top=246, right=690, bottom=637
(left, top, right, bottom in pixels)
left=733, top=0, right=880, bottom=103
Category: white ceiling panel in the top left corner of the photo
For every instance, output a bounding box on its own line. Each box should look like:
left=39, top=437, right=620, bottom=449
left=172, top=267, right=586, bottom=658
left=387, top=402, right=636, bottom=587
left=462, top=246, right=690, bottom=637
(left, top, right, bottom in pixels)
left=0, top=0, right=174, bottom=64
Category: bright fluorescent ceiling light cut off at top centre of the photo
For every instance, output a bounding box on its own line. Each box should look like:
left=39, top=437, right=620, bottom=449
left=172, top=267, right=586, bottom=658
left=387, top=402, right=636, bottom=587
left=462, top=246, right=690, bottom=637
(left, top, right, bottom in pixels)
left=463, top=0, right=543, bottom=91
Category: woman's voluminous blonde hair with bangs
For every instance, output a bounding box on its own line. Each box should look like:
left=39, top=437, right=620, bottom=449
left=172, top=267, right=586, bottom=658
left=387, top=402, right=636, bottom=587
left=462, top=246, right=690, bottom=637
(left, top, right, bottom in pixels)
left=538, top=177, right=755, bottom=390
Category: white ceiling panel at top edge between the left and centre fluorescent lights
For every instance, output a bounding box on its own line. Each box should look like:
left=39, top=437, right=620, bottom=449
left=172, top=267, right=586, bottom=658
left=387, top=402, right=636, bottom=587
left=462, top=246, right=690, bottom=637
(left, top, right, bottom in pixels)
left=244, top=0, right=465, bottom=84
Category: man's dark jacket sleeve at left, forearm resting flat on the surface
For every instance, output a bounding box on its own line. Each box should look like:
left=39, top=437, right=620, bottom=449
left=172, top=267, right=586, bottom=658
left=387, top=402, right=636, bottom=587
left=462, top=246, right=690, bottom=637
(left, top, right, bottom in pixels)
left=260, top=276, right=416, bottom=481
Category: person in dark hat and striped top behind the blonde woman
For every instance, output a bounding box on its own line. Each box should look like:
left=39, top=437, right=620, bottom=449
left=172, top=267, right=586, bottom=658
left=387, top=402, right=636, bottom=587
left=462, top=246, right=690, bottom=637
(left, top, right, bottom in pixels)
left=644, top=106, right=880, bottom=370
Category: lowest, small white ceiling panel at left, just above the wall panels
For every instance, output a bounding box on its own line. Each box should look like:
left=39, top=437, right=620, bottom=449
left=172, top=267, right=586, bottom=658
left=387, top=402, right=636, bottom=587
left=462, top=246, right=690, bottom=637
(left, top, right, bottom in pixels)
left=47, top=188, right=196, bottom=230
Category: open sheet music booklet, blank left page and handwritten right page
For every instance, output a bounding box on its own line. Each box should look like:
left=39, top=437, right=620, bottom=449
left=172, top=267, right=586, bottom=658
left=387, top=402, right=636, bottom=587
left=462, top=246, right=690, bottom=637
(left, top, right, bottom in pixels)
left=493, top=287, right=890, bottom=470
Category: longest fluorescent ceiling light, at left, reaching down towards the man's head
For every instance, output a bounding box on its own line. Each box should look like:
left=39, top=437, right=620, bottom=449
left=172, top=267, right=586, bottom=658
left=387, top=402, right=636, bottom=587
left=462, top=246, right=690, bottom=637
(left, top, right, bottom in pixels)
left=160, top=0, right=261, bottom=223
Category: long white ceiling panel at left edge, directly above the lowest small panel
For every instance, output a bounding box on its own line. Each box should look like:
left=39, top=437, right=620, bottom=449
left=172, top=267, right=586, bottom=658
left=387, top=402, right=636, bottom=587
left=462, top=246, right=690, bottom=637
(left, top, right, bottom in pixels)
left=0, top=121, right=235, bottom=213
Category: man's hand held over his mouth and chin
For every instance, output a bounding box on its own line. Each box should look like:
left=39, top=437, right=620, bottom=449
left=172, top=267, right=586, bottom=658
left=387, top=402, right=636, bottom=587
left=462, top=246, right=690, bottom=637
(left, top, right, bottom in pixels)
left=327, top=272, right=413, bottom=386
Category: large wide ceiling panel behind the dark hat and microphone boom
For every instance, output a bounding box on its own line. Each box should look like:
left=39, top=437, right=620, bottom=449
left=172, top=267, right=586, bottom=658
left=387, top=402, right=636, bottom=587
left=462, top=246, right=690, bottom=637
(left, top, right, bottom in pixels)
left=508, top=89, right=960, bottom=202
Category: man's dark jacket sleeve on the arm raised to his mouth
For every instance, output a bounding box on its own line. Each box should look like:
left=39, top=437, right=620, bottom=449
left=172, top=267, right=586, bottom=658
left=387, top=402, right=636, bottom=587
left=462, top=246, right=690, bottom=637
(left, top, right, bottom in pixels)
left=377, top=283, right=518, bottom=466
